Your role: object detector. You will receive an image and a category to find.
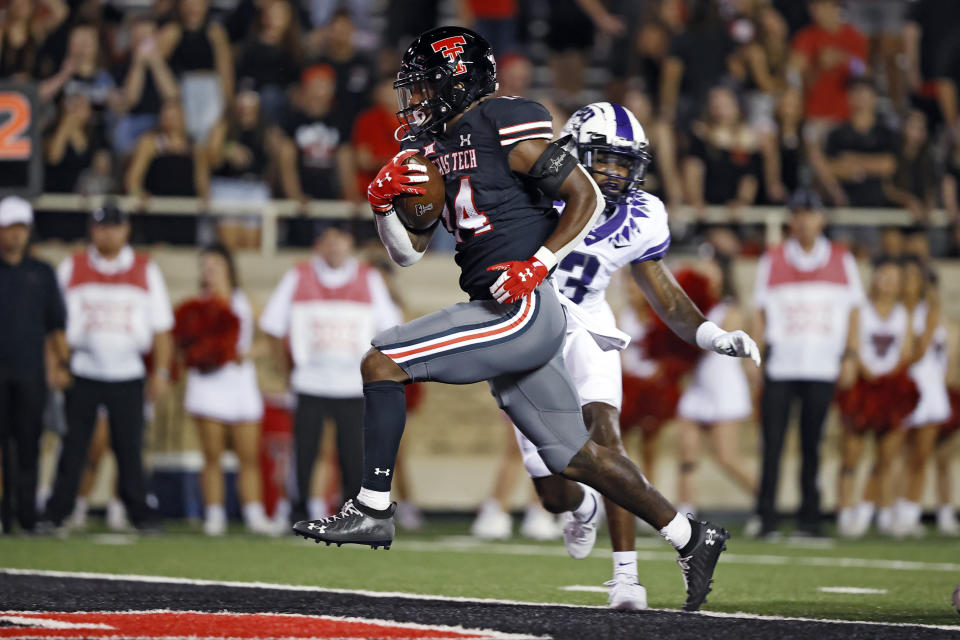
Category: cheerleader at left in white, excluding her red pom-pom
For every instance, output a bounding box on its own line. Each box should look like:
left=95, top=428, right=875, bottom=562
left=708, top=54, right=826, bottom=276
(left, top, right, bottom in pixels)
left=184, top=245, right=276, bottom=536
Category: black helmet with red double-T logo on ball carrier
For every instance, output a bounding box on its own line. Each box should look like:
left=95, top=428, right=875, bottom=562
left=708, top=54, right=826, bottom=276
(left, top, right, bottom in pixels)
left=393, top=27, right=497, bottom=137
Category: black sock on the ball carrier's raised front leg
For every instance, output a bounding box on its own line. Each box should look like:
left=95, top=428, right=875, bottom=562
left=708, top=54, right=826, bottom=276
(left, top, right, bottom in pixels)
left=363, top=380, right=407, bottom=491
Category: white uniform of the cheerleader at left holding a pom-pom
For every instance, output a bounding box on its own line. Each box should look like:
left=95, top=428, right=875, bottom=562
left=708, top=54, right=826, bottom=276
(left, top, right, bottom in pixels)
left=183, top=289, right=263, bottom=424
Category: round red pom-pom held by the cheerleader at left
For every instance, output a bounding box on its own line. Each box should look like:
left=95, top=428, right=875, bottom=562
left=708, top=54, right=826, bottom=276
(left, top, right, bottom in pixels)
left=173, top=298, right=240, bottom=372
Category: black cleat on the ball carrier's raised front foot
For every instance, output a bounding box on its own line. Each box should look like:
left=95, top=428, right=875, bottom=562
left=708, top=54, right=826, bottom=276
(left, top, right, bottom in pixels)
left=293, top=500, right=397, bottom=549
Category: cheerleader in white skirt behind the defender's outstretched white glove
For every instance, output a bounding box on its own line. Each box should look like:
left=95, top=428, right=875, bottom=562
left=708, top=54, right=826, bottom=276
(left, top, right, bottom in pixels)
left=677, top=252, right=756, bottom=514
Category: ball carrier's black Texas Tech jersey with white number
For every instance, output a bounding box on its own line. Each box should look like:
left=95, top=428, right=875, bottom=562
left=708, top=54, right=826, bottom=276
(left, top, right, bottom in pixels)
left=403, top=98, right=558, bottom=300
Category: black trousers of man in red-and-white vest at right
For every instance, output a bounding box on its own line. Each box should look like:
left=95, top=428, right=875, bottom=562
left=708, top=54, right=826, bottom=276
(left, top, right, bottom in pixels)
left=757, top=378, right=833, bottom=529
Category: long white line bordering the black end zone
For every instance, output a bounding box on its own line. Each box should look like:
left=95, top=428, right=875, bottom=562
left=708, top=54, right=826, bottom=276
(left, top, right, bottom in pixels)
left=0, top=567, right=960, bottom=631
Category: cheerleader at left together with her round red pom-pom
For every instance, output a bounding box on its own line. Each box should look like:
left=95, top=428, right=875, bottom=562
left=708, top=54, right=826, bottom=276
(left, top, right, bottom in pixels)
left=174, top=244, right=279, bottom=536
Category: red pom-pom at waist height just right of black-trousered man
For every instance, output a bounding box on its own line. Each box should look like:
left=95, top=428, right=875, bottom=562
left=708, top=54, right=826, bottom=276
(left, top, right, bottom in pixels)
left=836, top=370, right=920, bottom=433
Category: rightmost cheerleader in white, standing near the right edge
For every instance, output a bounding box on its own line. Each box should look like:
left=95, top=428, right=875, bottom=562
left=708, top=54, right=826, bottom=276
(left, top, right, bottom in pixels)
left=895, top=259, right=950, bottom=535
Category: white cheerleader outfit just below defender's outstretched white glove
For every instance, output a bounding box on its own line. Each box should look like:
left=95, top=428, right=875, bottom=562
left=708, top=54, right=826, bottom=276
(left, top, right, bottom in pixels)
left=677, top=302, right=752, bottom=424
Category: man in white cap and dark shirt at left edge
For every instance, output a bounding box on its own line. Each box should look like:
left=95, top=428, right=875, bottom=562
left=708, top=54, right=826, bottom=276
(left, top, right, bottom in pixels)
left=0, top=196, right=70, bottom=533
